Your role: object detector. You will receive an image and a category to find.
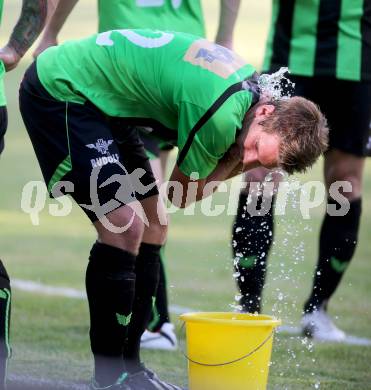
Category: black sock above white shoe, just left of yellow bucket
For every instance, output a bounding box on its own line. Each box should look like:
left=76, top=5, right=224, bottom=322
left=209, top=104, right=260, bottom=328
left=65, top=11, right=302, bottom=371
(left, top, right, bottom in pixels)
left=148, top=247, right=170, bottom=332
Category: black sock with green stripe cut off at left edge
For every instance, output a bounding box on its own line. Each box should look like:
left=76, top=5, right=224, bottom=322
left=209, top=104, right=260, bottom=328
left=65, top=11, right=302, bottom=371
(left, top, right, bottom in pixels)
left=0, top=260, right=11, bottom=389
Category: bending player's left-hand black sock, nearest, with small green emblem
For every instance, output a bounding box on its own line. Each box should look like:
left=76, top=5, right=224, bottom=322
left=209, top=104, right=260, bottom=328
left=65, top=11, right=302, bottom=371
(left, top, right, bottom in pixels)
left=86, top=242, right=135, bottom=386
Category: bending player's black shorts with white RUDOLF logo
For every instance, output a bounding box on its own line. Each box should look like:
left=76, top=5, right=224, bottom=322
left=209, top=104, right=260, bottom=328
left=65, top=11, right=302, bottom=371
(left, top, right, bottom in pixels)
left=20, top=64, right=158, bottom=222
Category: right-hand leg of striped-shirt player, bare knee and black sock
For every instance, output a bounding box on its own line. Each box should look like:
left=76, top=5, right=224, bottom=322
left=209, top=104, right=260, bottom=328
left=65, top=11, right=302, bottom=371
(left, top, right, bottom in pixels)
left=303, top=149, right=365, bottom=338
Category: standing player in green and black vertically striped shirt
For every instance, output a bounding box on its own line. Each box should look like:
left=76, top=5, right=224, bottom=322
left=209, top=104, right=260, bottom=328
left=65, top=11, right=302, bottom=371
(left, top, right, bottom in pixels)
left=233, top=0, right=371, bottom=341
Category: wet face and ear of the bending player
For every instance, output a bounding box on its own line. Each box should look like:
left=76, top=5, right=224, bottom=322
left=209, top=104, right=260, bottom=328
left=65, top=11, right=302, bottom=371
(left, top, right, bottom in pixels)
left=243, top=105, right=281, bottom=169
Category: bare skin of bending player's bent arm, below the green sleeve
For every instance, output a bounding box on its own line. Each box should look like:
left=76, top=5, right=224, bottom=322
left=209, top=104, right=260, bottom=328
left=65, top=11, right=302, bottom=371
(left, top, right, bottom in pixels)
left=168, top=144, right=243, bottom=208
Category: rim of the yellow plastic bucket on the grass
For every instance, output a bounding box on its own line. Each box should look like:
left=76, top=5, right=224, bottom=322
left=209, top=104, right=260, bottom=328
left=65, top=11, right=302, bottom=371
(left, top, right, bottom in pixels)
left=179, top=311, right=282, bottom=328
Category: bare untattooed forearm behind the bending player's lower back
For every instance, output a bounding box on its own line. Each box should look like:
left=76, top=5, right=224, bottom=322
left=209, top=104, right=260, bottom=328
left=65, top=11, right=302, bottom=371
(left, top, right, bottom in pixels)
left=33, top=0, right=78, bottom=57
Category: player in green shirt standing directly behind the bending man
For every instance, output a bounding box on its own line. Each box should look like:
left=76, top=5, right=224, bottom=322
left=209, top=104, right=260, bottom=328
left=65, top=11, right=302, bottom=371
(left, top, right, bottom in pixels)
left=35, top=0, right=240, bottom=350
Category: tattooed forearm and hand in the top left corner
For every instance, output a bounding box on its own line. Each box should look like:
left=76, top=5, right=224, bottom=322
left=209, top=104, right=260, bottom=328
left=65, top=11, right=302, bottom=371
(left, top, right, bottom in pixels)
left=0, top=0, right=48, bottom=71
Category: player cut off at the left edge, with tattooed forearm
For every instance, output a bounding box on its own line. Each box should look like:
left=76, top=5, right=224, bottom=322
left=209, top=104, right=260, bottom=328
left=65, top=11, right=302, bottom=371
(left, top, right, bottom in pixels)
left=0, top=0, right=48, bottom=389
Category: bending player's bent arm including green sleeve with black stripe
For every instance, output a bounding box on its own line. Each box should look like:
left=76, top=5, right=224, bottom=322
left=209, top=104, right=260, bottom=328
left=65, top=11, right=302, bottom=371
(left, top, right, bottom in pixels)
left=168, top=99, right=243, bottom=208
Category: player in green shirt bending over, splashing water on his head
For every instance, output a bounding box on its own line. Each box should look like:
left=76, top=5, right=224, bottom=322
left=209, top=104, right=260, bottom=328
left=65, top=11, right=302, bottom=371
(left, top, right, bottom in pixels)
left=20, top=30, right=327, bottom=390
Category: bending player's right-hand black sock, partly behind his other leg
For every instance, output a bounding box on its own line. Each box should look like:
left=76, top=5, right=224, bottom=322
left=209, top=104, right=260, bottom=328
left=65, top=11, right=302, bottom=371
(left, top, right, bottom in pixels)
left=124, top=243, right=161, bottom=372
